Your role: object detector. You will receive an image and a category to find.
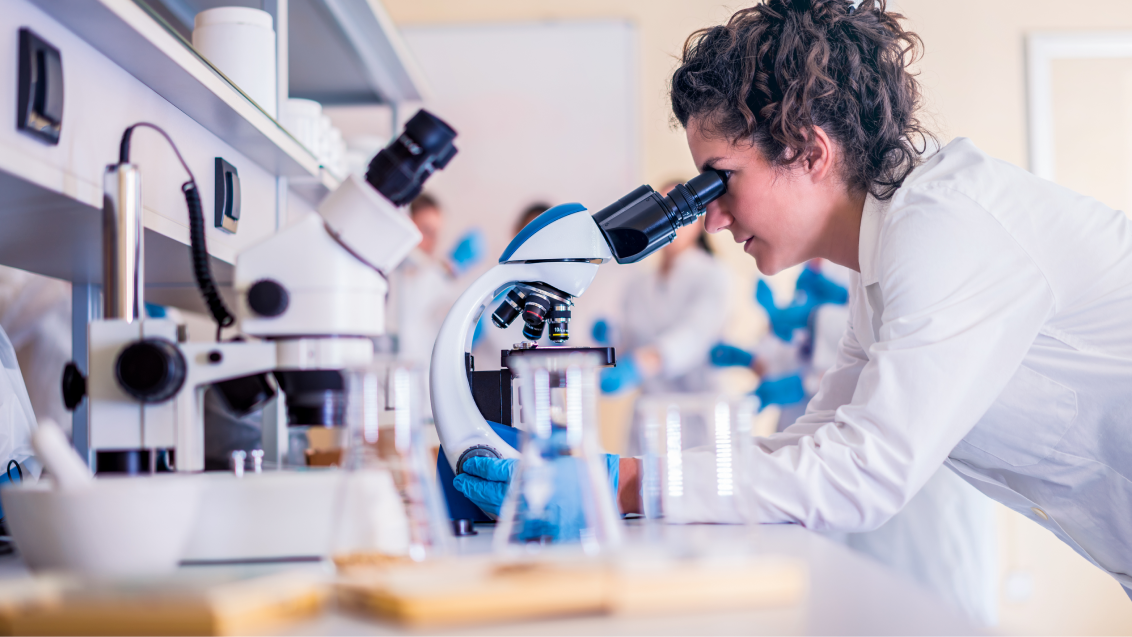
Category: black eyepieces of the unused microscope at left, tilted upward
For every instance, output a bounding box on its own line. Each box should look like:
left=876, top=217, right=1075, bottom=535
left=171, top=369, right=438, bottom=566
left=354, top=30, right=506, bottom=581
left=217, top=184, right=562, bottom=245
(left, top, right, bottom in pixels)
left=366, top=109, right=456, bottom=206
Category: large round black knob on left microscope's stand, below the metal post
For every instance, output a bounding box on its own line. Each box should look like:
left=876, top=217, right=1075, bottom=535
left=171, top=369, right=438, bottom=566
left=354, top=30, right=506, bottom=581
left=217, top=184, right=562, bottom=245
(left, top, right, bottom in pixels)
left=114, top=338, right=187, bottom=403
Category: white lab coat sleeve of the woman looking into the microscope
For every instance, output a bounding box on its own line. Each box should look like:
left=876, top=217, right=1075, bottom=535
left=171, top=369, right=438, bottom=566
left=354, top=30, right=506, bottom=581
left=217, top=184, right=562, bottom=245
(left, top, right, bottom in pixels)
left=747, top=186, right=1055, bottom=532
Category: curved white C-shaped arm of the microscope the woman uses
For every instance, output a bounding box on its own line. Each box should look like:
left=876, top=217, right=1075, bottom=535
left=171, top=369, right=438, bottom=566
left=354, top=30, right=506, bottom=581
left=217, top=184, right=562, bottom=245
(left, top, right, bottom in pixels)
left=429, top=260, right=600, bottom=473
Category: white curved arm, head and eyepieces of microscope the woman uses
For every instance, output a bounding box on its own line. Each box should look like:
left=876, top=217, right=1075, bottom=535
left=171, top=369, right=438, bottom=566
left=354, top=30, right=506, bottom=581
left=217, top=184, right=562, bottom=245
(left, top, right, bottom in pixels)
left=429, top=171, right=728, bottom=474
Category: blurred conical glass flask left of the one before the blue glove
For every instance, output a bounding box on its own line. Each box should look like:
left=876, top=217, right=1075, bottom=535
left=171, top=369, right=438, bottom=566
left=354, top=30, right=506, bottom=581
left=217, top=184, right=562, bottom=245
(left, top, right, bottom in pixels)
left=332, top=360, right=451, bottom=567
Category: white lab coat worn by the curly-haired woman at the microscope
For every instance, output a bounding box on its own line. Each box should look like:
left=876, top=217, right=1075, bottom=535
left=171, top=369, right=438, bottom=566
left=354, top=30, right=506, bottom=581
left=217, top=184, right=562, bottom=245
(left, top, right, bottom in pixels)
left=733, top=139, right=1132, bottom=587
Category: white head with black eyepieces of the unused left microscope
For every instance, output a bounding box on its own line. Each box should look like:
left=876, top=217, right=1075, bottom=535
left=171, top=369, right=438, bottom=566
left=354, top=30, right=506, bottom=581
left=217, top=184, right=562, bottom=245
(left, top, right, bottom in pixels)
left=235, top=110, right=456, bottom=425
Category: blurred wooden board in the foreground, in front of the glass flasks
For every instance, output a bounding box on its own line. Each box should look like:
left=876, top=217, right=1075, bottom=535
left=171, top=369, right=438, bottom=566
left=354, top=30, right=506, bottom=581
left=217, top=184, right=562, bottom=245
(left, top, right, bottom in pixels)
left=336, top=557, right=807, bottom=627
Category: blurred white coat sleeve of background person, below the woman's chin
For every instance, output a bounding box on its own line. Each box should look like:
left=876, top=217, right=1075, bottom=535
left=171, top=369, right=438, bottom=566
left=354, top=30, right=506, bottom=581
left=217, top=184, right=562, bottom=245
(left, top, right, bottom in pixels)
left=655, top=262, right=730, bottom=378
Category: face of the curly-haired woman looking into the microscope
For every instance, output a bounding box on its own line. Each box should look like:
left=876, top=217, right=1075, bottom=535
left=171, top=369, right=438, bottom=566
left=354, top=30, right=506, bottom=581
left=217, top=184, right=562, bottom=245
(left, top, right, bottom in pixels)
left=687, top=120, right=833, bottom=275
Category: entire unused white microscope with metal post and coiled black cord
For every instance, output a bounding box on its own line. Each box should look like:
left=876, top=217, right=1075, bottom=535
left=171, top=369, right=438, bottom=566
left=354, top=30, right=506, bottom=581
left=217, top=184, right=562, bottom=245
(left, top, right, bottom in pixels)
left=65, top=111, right=456, bottom=473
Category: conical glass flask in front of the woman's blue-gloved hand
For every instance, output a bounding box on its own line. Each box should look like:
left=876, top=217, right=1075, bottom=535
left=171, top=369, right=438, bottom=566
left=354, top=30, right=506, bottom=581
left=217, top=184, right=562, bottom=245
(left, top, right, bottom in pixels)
left=494, top=348, right=621, bottom=554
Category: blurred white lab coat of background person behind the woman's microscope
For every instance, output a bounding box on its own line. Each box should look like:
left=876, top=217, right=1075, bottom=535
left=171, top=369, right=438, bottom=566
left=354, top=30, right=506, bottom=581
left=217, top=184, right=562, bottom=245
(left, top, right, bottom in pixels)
left=621, top=248, right=730, bottom=394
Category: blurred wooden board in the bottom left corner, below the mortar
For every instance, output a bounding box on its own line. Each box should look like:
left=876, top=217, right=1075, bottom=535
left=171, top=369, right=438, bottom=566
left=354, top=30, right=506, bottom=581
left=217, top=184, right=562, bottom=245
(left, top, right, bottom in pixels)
left=0, top=571, right=328, bottom=637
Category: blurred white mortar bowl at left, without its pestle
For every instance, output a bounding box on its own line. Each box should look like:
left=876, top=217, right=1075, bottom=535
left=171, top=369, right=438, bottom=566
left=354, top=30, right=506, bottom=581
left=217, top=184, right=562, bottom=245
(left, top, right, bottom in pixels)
left=0, top=475, right=201, bottom=577
